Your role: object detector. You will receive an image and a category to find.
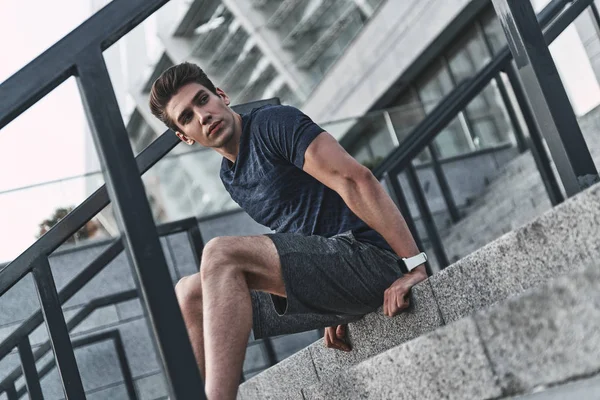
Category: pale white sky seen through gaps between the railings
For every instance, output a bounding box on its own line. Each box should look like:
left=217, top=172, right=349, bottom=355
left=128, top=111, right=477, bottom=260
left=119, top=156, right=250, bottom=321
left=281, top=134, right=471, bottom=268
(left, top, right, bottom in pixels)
left=0, top=0, right=600, bottom=262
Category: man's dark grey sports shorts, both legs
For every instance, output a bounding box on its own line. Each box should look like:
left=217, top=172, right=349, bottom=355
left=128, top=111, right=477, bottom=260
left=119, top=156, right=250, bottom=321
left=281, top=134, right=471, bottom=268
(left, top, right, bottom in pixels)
left=252, top=231, right=402, bottom=339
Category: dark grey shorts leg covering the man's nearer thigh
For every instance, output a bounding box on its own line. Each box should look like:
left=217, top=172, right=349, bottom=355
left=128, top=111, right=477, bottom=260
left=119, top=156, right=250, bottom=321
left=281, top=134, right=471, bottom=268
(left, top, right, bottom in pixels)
left=267, top=232, right=402, bottom=316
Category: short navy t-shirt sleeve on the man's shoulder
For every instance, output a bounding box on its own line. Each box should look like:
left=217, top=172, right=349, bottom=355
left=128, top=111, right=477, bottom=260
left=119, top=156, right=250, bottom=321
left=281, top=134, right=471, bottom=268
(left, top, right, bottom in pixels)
left=257, top=106, right=323, bottom=169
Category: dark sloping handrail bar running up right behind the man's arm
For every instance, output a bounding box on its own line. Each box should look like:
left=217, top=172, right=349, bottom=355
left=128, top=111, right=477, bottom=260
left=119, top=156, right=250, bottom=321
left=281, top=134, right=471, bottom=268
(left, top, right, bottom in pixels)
left=373, top=0, right=576, bottom=179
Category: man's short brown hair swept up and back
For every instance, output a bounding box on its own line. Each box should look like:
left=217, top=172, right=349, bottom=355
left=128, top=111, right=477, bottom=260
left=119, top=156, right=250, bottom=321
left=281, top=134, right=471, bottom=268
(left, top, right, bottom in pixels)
left=150, top=62, right=217, bottom=131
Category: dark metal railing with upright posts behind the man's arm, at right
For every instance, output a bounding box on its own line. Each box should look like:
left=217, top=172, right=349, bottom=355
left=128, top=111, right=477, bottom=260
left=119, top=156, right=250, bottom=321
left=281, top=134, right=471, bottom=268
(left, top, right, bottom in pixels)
left=373, top=0, right=600, bottom=274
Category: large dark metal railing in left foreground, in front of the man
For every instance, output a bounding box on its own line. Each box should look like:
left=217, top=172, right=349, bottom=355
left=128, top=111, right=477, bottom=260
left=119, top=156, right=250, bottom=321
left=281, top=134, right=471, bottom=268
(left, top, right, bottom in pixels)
left=0, top=0, right=278, bottom=399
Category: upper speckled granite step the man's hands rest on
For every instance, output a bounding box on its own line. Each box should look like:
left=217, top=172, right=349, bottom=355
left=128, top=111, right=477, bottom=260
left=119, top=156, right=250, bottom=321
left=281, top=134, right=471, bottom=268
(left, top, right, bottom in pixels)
left=239, top=185, right=600, bottom=400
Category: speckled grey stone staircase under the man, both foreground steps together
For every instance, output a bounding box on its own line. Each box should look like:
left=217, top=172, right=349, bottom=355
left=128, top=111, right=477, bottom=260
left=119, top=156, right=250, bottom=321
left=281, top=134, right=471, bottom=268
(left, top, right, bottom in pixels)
left=239, top=140, right=600, bottom=400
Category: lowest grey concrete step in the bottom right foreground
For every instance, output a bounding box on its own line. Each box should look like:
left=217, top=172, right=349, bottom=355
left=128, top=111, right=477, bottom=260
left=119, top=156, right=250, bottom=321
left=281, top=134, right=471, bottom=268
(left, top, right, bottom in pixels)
left=303, top=261, right=600, bottom=400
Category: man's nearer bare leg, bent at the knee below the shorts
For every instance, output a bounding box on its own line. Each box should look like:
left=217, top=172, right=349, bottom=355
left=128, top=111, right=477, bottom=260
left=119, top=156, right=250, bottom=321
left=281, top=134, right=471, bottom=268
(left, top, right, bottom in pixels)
left=201, top=236, right=285, bottom=400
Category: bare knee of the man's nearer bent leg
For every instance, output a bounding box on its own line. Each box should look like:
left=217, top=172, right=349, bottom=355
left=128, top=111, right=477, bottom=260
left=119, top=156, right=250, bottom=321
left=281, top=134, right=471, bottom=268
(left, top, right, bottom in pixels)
left=200, top=237, right=238, bottom=282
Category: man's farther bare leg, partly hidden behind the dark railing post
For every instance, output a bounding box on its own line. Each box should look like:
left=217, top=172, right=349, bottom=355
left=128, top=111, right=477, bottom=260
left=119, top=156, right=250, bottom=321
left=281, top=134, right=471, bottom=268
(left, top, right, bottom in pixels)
left=175, top=273, right=206, bottom=380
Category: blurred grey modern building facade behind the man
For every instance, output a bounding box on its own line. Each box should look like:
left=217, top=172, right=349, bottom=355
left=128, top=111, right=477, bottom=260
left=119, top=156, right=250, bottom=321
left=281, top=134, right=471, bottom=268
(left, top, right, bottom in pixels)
left=83, top=0, right=600, bottom=227
